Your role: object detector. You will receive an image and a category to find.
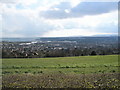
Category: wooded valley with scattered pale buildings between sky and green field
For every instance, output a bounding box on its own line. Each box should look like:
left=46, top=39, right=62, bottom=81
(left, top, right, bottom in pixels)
left=0, top=37, right=120, bottom=58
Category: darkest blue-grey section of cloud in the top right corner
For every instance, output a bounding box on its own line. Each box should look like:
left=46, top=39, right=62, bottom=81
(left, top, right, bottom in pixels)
left=72, top=2, right=117, bottom=15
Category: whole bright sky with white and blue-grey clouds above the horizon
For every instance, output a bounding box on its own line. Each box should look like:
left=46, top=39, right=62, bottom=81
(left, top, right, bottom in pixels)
left=0, top=0, right=118, bottom=37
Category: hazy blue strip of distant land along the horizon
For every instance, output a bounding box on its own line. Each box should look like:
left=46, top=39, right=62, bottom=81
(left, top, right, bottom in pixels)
left=0, top=36, right=118, bottom=42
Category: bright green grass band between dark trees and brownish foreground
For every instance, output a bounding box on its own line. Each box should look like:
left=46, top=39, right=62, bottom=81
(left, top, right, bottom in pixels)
left=2, top=55, right=118, bottom=74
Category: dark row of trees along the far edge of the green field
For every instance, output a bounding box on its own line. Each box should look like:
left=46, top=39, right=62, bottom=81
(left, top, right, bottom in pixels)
left=2, top=48, right=119, bottom=58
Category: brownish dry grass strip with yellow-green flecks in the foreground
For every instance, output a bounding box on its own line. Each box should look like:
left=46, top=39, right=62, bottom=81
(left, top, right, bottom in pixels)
left=2, top=73, right=120, bottom=88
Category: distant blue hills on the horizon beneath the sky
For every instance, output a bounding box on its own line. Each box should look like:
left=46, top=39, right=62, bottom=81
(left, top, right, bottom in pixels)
left=0, top=35, right=118, bottom=42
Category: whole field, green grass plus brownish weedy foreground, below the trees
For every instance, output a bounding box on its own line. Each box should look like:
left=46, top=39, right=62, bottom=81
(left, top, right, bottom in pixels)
left=2, top=55, right=120, bottom=88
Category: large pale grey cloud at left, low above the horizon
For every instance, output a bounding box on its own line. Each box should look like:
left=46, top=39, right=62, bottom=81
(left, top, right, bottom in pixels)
left=2, top=14, right=55, bottom=37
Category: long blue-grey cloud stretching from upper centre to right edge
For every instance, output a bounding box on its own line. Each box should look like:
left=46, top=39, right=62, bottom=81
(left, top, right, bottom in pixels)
left=40, top=2, right=118, bottom=19
